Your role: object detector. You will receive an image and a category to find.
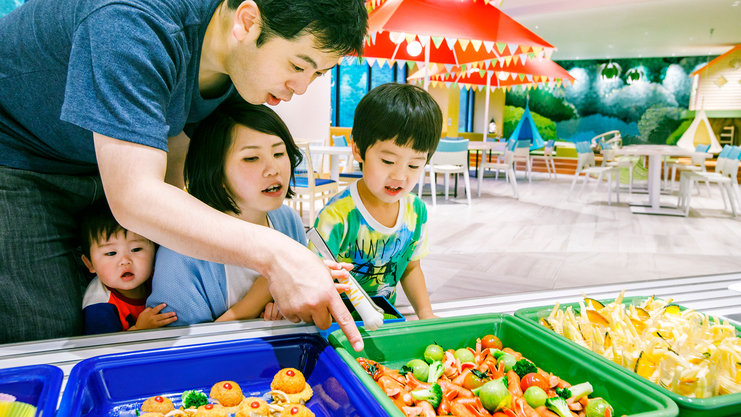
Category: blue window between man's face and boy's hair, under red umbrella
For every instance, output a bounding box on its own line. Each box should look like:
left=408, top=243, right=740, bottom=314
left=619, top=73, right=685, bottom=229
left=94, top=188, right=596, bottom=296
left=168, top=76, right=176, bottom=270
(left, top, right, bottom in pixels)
left=330, top=60, right=408, bottom=127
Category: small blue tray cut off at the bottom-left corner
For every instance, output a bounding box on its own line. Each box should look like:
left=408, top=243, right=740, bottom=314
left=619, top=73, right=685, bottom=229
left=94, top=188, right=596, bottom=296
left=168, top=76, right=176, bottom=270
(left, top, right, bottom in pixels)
left=0, top=365, right=64, bottom=417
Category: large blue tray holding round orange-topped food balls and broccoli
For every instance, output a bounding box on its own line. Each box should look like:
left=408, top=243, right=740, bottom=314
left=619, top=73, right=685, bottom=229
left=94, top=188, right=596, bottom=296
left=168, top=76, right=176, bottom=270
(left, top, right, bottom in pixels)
left=57, top=334, right=388, bottom=417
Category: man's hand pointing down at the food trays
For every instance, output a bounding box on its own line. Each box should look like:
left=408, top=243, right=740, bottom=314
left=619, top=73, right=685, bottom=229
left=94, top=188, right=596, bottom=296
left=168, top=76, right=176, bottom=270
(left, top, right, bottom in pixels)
left=266, top=243, right=363, bottom=352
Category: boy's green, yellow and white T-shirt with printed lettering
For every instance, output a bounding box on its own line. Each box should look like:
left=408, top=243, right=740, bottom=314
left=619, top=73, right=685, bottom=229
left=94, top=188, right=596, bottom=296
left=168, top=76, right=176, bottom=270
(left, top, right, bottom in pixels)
left=315, top=182, right=429, bottom=303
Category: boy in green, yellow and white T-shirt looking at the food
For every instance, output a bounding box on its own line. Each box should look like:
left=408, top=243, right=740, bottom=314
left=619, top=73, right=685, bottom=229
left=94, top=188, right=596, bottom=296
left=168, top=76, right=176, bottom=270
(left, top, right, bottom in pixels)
left=315, top=83, right=443, bottom=319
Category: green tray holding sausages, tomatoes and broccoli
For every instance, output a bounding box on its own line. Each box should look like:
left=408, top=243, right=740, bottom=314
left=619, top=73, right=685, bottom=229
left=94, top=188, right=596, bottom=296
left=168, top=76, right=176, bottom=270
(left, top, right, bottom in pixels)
left=329, top=314, right=679, bottom=417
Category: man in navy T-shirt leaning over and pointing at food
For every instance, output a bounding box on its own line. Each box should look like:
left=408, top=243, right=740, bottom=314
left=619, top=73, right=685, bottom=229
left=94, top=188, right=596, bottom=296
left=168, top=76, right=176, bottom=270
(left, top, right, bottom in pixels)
left=0, top=0, right=368, bottom=348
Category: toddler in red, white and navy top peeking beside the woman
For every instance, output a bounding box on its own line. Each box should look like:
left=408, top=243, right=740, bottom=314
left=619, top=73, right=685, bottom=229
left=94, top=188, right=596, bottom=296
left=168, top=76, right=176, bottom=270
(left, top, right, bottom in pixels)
left=81, top=200, right=177, bottom=334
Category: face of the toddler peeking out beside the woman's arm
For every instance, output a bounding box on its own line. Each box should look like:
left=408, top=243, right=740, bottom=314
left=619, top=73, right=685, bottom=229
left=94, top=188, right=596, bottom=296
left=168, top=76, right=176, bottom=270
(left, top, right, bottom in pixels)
left=83, top=230, right=154, bottom=291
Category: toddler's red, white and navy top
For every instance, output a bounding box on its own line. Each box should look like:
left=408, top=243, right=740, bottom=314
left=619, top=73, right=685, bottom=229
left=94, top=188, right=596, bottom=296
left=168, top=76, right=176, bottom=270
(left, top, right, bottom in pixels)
left=82, top=276, right=152, bottom=334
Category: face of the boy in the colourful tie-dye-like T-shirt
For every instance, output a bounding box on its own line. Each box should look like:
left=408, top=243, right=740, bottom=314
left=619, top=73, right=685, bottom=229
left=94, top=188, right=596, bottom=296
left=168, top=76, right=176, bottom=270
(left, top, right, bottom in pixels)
left=353, top=140, right=427, bottom=203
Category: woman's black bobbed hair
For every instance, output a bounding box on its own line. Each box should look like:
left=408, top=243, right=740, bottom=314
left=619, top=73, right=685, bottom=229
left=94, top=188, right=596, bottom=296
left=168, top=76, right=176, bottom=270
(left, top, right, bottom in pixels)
left=183, top=99, right=302, bottom=214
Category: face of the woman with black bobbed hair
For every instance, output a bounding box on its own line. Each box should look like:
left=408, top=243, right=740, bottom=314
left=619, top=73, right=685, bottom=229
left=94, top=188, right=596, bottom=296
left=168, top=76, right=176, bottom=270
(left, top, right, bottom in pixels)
left=224, top=125, right=291, bottom=224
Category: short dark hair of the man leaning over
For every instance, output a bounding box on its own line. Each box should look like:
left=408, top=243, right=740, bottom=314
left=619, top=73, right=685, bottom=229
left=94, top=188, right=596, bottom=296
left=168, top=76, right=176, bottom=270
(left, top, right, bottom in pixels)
left=227, top=0, right=368, bottom=56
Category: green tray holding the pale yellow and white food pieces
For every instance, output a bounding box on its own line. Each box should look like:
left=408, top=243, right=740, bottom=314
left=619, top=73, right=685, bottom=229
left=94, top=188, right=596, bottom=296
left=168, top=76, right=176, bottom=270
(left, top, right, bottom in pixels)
left=515, top=296, right=741, bottom=417
